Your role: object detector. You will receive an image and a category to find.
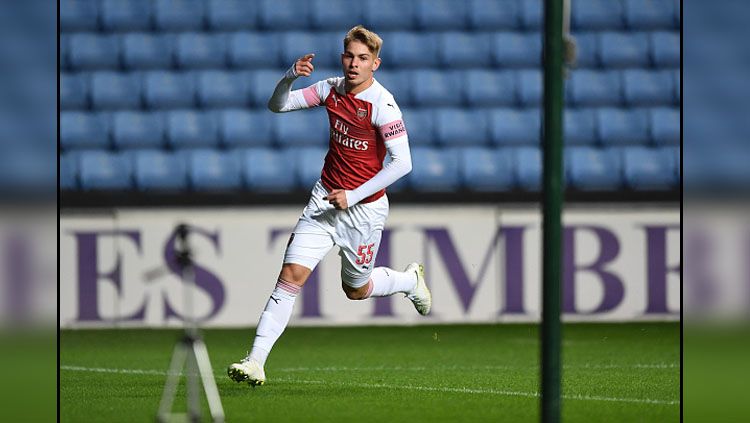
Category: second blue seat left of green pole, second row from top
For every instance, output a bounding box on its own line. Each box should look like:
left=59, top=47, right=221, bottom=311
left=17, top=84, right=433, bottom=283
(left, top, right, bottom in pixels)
left=438, top=32, right=492, bottom=68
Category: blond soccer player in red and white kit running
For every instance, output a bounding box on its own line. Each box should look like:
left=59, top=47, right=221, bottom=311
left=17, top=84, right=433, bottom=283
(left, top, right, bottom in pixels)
left=227, top=25, right=432, bottom=386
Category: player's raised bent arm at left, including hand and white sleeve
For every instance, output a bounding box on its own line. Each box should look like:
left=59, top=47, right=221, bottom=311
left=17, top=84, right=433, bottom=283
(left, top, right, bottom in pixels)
left=268, top=53, right=322, bottom=113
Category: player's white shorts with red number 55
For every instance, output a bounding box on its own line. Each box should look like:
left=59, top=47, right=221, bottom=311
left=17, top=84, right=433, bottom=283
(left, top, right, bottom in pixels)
left=284, top=181, right=388, bottom=288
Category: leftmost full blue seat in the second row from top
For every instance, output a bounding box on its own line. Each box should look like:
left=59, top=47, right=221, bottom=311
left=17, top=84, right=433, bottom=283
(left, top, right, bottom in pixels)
left=68, top=33, right=120, bottom=69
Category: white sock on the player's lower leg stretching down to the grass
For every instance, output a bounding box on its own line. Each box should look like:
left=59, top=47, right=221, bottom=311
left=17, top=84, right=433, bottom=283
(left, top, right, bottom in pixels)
left=250, top=279, right=302, bottom=365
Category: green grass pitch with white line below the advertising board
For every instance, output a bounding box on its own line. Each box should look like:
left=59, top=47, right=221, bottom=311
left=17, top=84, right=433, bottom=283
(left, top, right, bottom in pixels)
left=60, top=323, right=680, bottom=422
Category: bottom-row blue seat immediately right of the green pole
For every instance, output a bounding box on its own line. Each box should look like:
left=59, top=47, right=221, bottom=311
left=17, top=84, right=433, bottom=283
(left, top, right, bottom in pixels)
left=565, top=147, right=623, bottom=191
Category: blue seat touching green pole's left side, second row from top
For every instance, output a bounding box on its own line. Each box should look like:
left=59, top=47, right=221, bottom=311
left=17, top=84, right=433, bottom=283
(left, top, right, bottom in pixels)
left=492, top=32, right=542, bottom=68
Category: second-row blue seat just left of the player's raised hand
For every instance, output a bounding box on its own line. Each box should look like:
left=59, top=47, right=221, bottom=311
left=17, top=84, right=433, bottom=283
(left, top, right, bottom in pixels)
left=227, top=32, right=282, bottom=68
